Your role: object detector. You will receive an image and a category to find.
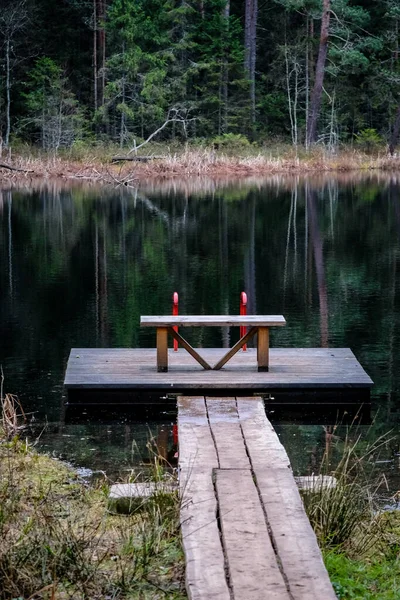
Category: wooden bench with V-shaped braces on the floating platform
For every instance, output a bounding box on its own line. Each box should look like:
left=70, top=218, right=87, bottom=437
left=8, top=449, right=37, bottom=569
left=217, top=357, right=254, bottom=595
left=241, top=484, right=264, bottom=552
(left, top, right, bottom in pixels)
left=140, top=315, right=286, bottom=372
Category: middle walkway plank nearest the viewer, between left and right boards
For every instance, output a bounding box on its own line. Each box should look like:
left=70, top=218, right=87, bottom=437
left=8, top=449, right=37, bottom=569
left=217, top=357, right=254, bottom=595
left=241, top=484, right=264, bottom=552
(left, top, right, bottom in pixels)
left=215, top=469, right=290, bottom=600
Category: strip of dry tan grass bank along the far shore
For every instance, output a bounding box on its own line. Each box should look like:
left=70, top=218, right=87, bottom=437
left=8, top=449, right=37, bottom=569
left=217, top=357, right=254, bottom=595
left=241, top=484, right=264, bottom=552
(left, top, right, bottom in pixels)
left=0, top=143, right=400, bottom=185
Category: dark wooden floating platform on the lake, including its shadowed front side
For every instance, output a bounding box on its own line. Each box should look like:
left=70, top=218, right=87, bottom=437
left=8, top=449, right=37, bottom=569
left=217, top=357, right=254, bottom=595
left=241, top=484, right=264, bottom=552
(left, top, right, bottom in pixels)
left=64, top=348, right=373, bottom=404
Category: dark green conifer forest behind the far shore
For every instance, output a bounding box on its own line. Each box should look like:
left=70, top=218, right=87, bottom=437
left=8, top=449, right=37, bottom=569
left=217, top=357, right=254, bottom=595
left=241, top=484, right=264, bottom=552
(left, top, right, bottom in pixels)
left=0, top=0, right=400, bottom=153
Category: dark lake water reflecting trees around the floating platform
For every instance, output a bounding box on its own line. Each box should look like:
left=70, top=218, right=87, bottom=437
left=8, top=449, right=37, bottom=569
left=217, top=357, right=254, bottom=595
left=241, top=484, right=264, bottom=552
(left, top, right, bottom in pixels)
left=0, top=174, right=400, bottom=489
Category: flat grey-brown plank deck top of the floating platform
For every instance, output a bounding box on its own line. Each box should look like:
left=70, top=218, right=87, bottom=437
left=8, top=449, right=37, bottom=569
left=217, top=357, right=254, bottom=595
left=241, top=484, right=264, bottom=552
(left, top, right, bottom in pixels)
left=64, top=348, right=373, bottom=399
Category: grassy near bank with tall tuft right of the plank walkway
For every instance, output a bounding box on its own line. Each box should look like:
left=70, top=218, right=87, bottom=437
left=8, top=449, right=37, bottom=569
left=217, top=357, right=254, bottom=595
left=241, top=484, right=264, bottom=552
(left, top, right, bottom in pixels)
left=303, top=436, right=400, bottom=600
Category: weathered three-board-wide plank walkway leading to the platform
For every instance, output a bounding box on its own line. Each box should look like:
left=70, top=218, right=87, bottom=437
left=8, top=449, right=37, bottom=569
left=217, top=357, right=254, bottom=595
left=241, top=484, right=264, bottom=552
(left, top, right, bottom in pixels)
left=178, top=396, right=336, bottom=600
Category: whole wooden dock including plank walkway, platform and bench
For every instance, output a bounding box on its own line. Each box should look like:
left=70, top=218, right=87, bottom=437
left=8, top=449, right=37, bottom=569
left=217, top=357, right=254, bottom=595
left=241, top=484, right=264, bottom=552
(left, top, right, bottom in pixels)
left=65, top=315, right=372, bottom=600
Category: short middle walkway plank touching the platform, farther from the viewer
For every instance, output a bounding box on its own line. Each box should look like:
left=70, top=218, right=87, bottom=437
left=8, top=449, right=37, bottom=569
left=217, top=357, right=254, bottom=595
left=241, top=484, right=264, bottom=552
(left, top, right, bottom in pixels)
left=206, top=397, right=250, bottom=469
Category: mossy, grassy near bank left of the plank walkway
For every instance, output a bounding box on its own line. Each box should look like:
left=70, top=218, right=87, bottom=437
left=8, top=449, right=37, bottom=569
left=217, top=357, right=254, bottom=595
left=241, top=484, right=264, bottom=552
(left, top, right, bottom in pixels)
left=0, top=437, right=186, bottom=600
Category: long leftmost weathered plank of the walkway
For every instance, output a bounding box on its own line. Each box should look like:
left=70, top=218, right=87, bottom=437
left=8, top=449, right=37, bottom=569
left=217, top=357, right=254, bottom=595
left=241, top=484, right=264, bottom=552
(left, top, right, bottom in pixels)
left=178, top=397, right=230, bottom=600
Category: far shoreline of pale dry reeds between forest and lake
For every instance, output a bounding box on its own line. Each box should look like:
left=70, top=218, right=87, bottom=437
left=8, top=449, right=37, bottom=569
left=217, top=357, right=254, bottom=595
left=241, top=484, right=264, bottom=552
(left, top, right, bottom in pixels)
left=0, top=149, right=400, bottom=186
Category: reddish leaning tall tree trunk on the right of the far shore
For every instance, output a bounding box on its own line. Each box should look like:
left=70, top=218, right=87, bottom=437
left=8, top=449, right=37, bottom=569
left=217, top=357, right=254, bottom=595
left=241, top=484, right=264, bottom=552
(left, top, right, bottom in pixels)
left=306, top=0, right=331, bottom=147
